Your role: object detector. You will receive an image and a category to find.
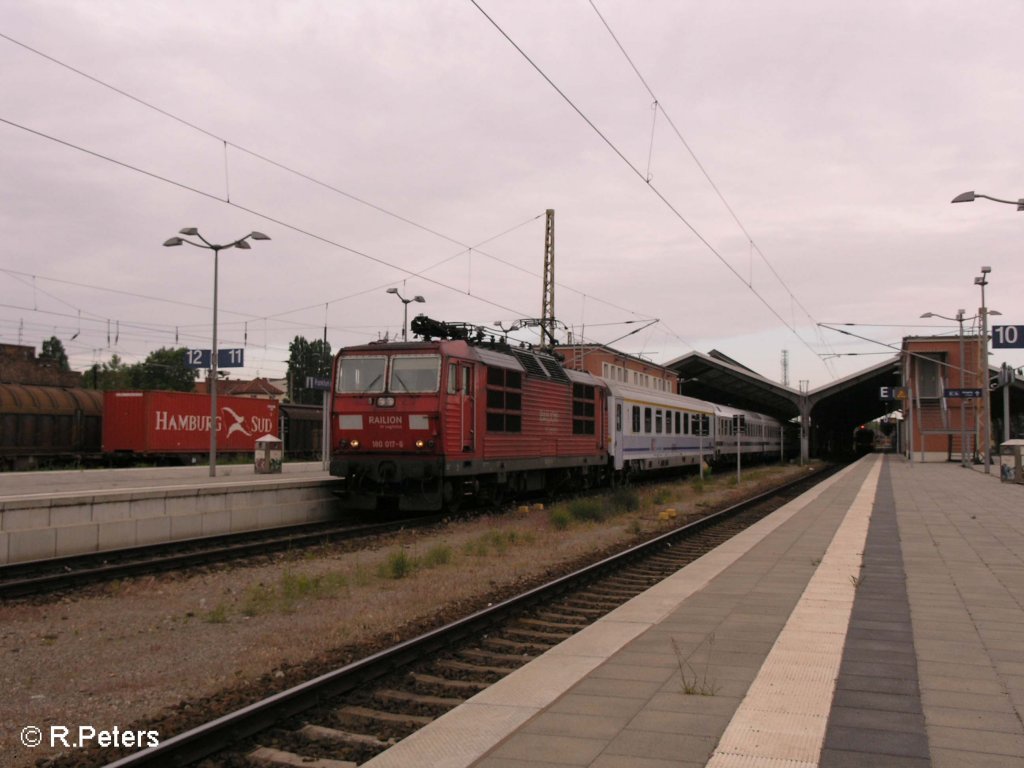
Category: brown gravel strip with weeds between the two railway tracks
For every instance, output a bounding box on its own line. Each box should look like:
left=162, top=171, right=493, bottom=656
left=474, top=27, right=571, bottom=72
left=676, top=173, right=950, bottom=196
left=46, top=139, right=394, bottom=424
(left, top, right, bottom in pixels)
left=0, top=467, right=808, bottom=768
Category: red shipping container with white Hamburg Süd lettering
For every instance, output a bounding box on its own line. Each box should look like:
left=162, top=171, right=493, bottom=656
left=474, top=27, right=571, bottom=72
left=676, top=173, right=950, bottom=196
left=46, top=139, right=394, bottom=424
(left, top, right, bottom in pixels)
left=103, top=391, right=279, bottom=454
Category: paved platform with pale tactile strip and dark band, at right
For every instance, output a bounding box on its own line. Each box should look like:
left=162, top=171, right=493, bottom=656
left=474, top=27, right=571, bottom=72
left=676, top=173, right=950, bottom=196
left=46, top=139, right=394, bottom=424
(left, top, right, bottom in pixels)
left=364, top=455, right=1024, bottom=768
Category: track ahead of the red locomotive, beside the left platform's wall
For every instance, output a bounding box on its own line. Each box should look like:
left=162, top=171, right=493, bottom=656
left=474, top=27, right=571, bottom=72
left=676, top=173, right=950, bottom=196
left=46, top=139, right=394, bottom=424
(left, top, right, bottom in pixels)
left=0, top=515, right=442, bottom=599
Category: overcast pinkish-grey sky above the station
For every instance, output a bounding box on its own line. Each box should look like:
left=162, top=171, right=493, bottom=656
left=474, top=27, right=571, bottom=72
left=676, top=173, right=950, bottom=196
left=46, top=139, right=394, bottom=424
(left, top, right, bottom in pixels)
left=0, top=0, right=1024, bottom=388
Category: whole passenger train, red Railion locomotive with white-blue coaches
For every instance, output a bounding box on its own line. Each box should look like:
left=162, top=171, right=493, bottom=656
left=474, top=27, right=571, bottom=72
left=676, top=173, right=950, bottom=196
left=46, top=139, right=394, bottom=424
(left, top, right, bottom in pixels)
left=331, top=331, right=782, bottom=511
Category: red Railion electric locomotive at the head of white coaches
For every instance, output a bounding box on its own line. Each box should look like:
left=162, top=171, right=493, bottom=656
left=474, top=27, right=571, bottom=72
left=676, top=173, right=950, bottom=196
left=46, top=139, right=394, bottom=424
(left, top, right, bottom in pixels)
left=331, top=317, right=608, bottom=511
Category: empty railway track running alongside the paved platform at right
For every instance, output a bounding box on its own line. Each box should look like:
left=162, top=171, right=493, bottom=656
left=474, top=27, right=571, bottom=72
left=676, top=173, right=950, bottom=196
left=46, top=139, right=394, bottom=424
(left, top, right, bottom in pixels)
left=92, top=468, right=837, bottom=768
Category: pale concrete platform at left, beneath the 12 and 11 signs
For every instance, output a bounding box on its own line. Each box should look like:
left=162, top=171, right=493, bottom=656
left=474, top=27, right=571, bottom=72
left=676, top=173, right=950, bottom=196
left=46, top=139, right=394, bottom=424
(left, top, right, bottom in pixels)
left=0, top=462, right=336, bottom=565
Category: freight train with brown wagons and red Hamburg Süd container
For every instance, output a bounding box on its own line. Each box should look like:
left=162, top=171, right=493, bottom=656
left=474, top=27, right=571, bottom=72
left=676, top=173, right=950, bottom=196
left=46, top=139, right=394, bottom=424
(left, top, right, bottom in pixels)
left=0, top=384, right=323, bottom=470
